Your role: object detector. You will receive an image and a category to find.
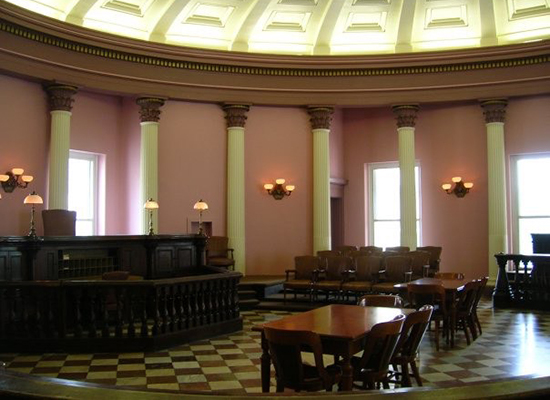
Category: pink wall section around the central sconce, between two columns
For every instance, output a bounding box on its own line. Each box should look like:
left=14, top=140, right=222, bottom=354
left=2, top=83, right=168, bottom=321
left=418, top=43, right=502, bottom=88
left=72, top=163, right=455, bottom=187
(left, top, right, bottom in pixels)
left=245, top=106, right=313, bottom=274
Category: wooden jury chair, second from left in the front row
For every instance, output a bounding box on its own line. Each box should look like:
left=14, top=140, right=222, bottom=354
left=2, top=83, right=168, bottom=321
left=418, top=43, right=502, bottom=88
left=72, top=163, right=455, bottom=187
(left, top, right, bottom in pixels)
left=313, top=256, right=353, bottom=301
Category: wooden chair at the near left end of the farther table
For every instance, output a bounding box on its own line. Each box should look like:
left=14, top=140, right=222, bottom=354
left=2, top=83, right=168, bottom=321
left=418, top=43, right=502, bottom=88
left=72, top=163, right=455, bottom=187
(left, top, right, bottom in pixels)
left=407, top=283, right=450, bottom=351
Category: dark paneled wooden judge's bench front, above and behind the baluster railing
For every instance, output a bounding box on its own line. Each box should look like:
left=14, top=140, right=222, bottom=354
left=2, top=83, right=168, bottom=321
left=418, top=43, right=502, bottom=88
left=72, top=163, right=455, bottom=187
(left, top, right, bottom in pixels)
left=0, top=235, right=206, bottom=281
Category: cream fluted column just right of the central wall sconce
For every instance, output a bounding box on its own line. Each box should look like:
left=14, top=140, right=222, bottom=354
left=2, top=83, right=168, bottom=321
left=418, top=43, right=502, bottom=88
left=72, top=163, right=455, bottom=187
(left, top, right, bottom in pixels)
left=308, top=106, right=334, bottom=254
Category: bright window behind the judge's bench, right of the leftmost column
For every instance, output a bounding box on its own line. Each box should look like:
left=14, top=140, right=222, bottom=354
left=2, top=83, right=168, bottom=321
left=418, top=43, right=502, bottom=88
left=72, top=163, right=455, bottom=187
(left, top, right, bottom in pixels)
left=69, top=150, right=99, bottom=236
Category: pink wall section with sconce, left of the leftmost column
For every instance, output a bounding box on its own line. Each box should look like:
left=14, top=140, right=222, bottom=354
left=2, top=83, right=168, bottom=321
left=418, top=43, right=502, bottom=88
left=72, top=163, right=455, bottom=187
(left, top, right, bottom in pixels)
left=0, top=75, right=50, bottom=235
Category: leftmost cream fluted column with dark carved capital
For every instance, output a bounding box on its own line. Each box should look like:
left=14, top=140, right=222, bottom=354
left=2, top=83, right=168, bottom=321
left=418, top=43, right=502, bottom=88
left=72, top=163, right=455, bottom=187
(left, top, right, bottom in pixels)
left=44, top=84, right=78, bottom=210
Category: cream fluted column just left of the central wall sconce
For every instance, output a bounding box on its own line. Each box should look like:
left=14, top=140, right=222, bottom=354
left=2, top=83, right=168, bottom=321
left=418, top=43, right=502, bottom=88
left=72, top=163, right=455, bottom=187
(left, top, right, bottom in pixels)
left=223, top=104, right=250, bottom=274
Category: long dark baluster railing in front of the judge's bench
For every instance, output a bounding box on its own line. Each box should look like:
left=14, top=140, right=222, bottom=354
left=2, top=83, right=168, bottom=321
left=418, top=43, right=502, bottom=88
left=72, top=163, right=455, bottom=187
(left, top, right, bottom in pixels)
left=0, top=267, right=242, bottom=352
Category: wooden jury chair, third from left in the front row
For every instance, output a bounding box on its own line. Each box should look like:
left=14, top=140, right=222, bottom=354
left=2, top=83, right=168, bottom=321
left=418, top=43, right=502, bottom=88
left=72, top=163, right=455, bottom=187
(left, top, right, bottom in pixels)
left=342, top=253, right=382, bottom=299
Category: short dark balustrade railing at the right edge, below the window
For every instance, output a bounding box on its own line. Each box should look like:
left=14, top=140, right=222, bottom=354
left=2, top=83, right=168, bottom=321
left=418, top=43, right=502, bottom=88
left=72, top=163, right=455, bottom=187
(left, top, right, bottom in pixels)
left=493, top=253, right=550, bottom=310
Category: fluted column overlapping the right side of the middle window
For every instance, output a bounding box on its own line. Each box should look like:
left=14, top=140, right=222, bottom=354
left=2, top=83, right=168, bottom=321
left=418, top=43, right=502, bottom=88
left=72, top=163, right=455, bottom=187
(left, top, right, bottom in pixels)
left=392, top=104, right=418, bottom=250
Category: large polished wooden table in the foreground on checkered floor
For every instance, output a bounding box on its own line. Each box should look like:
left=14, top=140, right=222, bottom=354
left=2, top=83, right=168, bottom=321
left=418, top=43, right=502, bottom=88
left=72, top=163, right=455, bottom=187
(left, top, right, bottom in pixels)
left=252, top=304, right=414, bottom=393
